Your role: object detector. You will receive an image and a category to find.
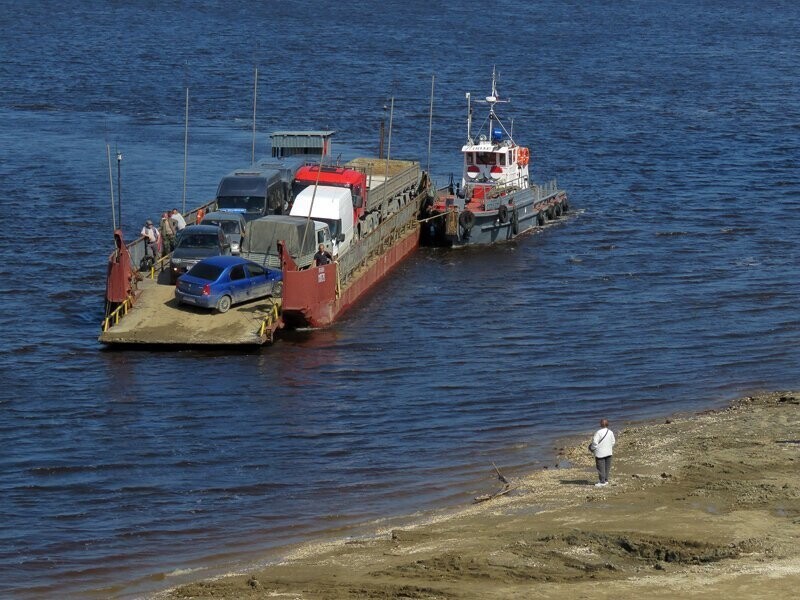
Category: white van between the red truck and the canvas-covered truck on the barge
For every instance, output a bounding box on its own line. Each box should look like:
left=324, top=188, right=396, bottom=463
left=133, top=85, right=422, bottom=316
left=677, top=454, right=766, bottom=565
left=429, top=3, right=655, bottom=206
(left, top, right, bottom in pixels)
left=289, top=185, right=354, bottom=256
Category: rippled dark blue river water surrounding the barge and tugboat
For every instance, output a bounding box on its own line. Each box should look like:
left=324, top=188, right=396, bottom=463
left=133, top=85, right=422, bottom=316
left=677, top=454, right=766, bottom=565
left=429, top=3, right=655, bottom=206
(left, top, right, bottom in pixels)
left=0, top=0, right=800, bottom=598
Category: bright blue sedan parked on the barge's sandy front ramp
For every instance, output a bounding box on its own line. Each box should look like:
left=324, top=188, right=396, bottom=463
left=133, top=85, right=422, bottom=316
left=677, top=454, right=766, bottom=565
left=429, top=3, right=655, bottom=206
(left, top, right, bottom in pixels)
left=175, top=256, right=283, bottom=313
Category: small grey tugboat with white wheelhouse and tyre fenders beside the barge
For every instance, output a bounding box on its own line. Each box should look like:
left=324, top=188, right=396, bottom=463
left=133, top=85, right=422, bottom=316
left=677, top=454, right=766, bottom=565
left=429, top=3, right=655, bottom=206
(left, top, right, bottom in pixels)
left=421, top=71, right=569, bottom=247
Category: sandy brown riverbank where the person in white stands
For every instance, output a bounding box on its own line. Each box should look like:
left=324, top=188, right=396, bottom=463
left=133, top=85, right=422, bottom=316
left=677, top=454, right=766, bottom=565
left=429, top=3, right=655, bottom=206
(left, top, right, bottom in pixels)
left=159, top=392, right=800, bottom=600
